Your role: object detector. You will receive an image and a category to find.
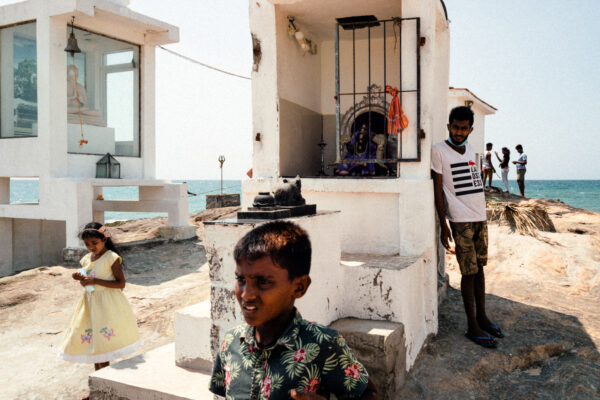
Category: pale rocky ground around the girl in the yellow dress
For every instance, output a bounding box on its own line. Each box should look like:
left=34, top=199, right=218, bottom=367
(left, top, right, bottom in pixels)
left=0, top=241, right=210, bottom=399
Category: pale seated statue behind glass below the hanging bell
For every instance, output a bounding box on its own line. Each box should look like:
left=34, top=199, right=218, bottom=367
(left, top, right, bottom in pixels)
left=67, top=65, right=106, bottom=126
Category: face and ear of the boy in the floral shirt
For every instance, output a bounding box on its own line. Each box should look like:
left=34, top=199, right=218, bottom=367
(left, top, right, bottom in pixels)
left=235, top=256, right=310, bottom=329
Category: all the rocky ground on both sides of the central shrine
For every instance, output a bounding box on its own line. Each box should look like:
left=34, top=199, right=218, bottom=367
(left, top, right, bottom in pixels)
left=0, top=200, right=600, bottom=399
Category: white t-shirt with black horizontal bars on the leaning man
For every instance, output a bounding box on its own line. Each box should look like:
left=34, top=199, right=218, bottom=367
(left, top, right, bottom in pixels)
left=431, top=141, right=487, bottom=222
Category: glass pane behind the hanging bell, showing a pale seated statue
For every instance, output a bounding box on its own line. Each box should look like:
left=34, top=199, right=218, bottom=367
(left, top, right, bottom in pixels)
left=66, top=28, right=140, bottom=157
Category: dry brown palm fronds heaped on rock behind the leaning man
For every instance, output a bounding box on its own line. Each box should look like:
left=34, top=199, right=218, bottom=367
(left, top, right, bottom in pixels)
left=488, top=203, right=556, bottom=237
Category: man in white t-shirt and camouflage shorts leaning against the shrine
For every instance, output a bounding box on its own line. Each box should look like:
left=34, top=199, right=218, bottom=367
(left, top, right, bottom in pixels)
left=431, top=107, right=504, bottom=347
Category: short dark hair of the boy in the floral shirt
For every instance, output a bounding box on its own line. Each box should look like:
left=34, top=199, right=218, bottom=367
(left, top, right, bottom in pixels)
left=233, top=221, right=312, bottom=280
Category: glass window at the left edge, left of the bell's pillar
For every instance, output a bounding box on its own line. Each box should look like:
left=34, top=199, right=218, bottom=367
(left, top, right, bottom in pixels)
left=0, top=22, right=37, bottom=138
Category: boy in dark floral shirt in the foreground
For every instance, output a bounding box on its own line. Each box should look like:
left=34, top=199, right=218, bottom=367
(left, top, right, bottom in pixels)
left=210, top=221, right=377, bottom=400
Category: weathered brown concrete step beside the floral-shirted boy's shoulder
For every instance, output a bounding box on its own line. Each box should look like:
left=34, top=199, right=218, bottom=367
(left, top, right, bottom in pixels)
left=330, top=318, right=406, bottom=400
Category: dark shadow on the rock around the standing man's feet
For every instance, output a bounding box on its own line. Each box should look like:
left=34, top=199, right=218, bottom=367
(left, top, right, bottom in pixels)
left=400, top=287, right=600, bottom=399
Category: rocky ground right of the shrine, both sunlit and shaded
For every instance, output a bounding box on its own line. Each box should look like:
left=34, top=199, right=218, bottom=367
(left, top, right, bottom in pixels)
left=402, top=192, right=600, bottom=399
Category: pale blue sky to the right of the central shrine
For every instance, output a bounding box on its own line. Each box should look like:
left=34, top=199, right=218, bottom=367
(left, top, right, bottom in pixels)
left=446, top=0, right=600, bottom=179
